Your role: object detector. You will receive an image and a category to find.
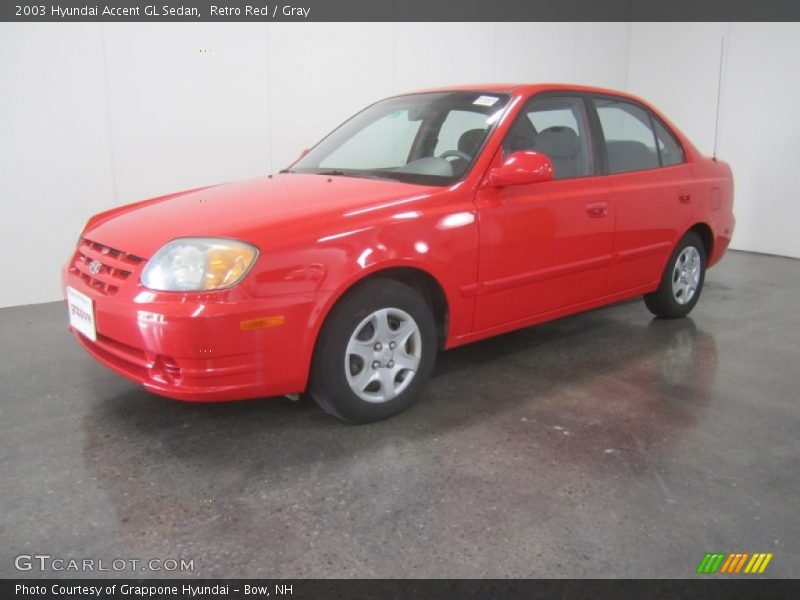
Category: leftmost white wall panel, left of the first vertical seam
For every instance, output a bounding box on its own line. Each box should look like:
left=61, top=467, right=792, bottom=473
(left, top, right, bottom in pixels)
left=0, top=23, right=117, bottom=306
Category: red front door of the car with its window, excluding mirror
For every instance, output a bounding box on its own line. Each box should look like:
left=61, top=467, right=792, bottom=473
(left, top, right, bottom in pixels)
left=474, top=93, right=614, bottom=330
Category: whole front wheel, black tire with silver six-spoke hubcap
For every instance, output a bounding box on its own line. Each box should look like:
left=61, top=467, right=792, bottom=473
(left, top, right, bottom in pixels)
left=309, top=279, right=437, bottom=423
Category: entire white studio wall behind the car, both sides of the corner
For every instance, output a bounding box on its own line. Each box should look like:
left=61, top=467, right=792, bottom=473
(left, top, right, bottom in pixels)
left=0, top=23, right=800, bottom=306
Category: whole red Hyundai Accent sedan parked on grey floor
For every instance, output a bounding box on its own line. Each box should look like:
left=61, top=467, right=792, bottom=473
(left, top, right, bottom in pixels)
left=64, top=85, right=734, bottom=422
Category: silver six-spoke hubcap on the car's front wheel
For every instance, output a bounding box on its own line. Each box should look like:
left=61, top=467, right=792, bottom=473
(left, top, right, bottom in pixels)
left=344, top=308, right=422, bottom=403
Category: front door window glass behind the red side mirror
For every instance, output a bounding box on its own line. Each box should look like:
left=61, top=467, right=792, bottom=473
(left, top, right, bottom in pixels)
left=503, top=96, right=594, bottom=179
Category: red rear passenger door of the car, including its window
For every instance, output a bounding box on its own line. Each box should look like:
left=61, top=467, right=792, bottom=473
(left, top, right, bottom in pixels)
left=592, top=96, right=695, bottom=294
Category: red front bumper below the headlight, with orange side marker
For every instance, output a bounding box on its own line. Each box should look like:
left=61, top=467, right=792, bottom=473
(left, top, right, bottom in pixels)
left=63, top=266, right=322, bottom=402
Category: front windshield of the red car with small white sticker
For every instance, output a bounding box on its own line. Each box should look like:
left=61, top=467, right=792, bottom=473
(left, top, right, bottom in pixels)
left=286, top=92, right=508, bottom=185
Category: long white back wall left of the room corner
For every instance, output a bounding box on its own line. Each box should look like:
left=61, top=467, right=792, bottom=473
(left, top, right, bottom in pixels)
left=0, top=23, right=628, bottom=306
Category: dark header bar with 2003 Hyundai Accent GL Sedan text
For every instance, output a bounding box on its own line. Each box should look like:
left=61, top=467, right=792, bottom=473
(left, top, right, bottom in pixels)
left=0, top=0, right=800, bottom=22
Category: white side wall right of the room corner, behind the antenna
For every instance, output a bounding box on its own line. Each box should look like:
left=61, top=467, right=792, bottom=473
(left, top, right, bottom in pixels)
left=628, top=23, right=800, bottom=258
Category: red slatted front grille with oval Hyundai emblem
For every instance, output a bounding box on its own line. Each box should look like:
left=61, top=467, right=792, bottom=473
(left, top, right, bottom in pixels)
left=69, top=238, right=144, bottom=296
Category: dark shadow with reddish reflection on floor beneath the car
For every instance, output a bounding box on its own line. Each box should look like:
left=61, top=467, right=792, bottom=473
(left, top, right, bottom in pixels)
left=84, top=305, right=716, bottom=470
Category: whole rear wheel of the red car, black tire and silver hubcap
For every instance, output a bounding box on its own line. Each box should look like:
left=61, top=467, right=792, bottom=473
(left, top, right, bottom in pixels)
left=644, top=231, right=706, bottom=319
